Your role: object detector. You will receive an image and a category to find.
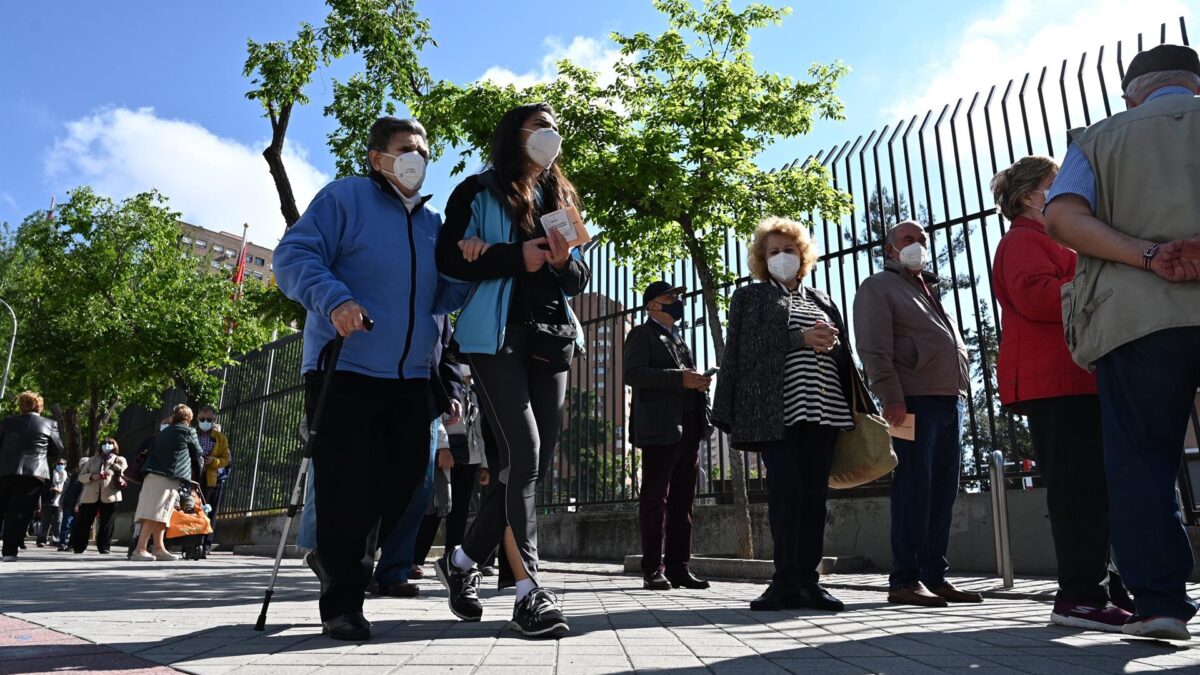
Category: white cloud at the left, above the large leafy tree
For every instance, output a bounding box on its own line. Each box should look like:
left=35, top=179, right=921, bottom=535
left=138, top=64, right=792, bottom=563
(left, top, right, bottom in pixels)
left=44, top=108, right=329, bottom=247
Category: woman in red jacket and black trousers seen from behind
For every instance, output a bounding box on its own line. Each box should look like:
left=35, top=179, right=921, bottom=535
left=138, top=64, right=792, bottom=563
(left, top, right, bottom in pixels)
left=991, top=156, right=1133, bottom=633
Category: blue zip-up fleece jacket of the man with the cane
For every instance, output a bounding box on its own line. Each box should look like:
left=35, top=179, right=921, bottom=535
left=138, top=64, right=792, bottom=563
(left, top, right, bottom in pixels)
left=275, top=175, right=469, bottom=380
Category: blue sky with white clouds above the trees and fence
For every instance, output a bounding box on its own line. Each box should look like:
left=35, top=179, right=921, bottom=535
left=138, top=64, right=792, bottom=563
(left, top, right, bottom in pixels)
left=0, top=0, right=1198, bottom=246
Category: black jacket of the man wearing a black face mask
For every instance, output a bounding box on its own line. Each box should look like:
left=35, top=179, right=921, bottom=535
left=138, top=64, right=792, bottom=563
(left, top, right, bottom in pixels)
left=624, top=319, right=710, bottom=448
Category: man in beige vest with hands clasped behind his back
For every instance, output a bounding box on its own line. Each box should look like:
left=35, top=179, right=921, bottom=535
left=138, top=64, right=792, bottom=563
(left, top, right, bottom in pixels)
left=1045, top=44, right=1200, bottom=640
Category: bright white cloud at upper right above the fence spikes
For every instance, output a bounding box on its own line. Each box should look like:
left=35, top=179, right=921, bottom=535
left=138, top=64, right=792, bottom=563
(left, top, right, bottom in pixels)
left=884, top=0, right=1190, bottom=120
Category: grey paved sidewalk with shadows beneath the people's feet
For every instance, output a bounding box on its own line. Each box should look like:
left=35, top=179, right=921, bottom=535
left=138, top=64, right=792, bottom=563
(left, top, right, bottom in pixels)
left=0, top=550, right=1200, bottom=675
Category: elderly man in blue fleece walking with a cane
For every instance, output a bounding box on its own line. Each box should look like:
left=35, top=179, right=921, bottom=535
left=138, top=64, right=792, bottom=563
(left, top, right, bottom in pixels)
left=275, top=117, right=464, bottom=641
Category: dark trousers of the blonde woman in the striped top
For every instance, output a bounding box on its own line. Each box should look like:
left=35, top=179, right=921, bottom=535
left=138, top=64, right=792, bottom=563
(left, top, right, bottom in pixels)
left=762, top=422, right=839, bottom=592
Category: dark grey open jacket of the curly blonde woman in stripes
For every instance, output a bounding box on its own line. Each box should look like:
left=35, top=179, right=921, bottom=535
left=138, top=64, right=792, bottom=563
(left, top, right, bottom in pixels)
left=713, top=282, right=876, bottom=450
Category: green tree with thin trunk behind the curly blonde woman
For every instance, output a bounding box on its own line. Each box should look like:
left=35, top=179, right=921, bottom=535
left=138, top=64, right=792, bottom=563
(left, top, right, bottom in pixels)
left=412, top=0, right=848, bottom=557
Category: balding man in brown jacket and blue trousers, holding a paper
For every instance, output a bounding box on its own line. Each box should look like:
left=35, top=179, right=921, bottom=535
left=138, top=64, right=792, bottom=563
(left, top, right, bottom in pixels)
left=854, top=221, right=983, bottom=607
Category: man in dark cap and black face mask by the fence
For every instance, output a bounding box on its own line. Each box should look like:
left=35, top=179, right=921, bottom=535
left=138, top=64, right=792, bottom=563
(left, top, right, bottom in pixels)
left=624, top=281, right=713, bottom=591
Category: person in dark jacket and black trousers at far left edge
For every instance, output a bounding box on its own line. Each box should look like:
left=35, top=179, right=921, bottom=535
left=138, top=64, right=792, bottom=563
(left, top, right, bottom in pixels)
left=0, top=392, right=64, bottom=562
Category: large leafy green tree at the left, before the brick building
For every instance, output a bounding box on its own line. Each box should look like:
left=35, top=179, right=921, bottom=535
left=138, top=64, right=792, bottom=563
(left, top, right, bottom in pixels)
left=0, top=187, right=270, bottom=462
